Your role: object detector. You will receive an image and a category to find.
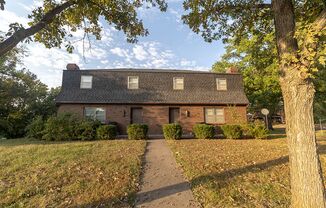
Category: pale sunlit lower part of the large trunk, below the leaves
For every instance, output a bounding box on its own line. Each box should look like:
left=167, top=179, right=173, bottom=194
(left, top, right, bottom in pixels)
left=282, top=78, right=326, bottom=208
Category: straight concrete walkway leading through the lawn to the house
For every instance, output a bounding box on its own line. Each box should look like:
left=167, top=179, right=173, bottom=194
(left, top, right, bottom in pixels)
left=136, top=139, right=200, bottom=208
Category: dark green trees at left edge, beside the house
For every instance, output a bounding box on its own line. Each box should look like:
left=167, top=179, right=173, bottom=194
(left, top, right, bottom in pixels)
left=0, top=48, right=59, bottom=138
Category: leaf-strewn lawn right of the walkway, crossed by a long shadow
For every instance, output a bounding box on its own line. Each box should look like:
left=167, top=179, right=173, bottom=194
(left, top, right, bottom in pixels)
left=168, top=132, right=326, bottom=207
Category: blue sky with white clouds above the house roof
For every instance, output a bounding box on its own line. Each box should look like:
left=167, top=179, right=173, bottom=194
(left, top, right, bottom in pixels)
left=0, top=0, right=224, bottom=87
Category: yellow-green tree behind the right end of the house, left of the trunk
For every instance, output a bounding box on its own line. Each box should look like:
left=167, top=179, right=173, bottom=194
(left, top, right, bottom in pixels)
left=212, top=33, right=282, bottom=129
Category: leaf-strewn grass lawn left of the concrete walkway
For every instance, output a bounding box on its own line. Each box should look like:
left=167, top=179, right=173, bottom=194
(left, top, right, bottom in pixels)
left=0, top=139, right=145, bottom=207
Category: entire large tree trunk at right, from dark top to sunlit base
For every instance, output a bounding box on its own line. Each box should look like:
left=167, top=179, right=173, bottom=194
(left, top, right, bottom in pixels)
left=273, top=0, right=326, bottom=208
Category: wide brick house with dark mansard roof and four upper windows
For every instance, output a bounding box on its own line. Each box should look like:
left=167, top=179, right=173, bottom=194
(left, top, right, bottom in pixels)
left=56, top=64, right=248, bottom=135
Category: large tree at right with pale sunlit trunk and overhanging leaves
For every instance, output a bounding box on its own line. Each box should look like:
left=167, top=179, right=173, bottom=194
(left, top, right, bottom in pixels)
left=183, top=0, right=326, bottom=208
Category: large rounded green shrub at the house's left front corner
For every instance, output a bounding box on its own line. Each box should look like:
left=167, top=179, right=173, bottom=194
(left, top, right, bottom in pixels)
left=42, top=114, right=79, bottom=141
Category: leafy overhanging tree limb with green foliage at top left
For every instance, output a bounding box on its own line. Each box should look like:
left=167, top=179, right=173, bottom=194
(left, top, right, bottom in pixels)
left=0, top=0, right=167, bottom=56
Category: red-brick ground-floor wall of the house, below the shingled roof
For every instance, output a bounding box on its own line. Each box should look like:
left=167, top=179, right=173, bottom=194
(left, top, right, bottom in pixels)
left=58, top=104, right=247, bottom=135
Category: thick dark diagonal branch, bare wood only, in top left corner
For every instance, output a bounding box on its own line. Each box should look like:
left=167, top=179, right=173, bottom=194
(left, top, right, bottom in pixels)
left=0, top=1, right=75, bottom=57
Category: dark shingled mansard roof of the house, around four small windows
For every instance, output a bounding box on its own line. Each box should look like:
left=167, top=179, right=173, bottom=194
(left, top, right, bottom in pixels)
left=56, top=69, right=248, bottom=104
